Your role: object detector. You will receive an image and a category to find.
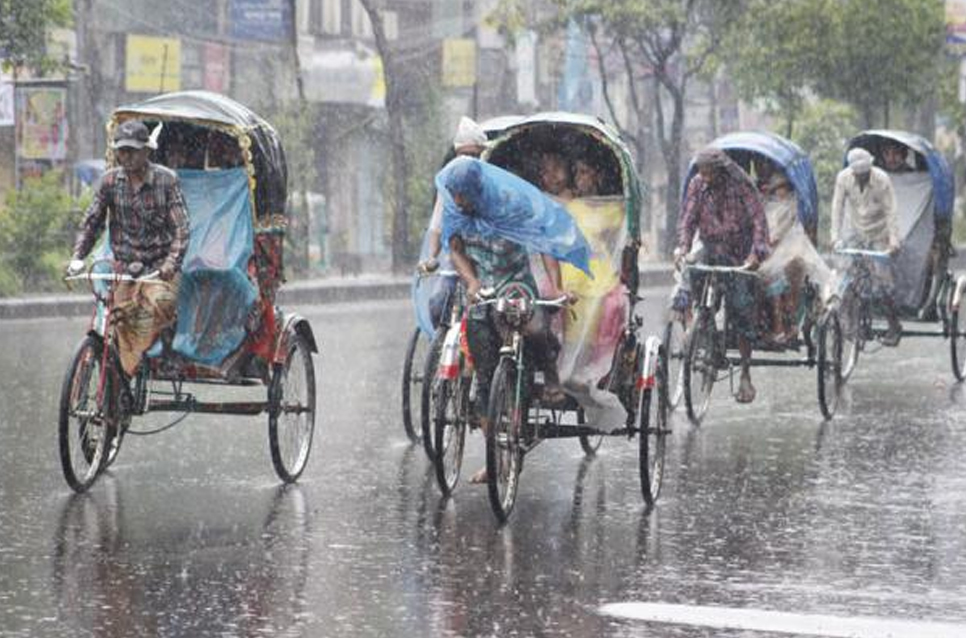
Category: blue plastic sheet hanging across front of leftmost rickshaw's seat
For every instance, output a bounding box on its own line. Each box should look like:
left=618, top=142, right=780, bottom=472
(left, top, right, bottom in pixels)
left=173, top=168, right=258, bottom=366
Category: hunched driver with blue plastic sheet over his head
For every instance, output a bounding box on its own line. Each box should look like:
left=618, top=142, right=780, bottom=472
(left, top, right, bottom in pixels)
left=436, top=158, right=590, bottom=482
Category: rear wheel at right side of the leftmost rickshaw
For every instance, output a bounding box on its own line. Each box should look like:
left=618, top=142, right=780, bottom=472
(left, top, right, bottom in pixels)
left=268, top=333, right=315, bottom=483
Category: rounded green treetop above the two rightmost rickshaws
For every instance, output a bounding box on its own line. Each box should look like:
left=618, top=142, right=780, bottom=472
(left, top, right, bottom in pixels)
left=726, top=0, right=944, bottom=131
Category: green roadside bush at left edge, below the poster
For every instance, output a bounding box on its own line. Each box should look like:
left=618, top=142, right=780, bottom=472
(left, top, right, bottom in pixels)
left=0, top=171, right=83, bottom=295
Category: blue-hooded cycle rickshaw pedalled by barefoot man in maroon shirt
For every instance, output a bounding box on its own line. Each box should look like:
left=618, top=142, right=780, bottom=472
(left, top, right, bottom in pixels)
left=664, top=131, right=842, bottom=425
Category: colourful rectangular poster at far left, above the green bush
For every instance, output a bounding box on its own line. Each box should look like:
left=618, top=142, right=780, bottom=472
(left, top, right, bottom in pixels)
left=16, top=86, right=67, bottom=161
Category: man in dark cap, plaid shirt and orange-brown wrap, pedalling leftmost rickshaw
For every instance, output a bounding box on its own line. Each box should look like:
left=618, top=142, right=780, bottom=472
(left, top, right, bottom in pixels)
left=67, top=120, right=188, bottom=376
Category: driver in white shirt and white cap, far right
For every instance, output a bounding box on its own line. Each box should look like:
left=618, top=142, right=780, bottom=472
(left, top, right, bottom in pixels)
left=831, top=148, right=902, bottom=345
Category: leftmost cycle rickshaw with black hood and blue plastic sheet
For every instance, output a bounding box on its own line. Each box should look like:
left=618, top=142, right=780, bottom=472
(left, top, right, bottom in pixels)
left=59, top=91, right=318, bottom=492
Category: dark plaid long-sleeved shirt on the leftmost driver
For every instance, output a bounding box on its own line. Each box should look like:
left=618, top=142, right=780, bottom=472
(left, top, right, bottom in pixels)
left=74, top=163, right=189, bottom=271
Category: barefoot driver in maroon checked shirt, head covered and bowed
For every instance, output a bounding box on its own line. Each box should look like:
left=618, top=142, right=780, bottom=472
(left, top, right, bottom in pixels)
left=674, top=147, right=769, bottom=403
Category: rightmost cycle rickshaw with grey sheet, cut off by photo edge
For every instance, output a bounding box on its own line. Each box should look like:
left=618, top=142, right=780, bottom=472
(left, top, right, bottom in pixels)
left=835, top=130, right=966, bottom=381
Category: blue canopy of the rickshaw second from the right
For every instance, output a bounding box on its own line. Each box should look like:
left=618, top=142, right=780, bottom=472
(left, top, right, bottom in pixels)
left=683, top=131, right=818, bottom=236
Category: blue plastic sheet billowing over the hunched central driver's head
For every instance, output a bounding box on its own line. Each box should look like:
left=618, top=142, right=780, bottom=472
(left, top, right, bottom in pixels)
left=436, top=157, right=591, bottom=275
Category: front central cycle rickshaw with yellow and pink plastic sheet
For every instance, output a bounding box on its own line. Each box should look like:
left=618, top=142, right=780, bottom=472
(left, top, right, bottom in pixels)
left=427, top=113, right=670, bottom=523
